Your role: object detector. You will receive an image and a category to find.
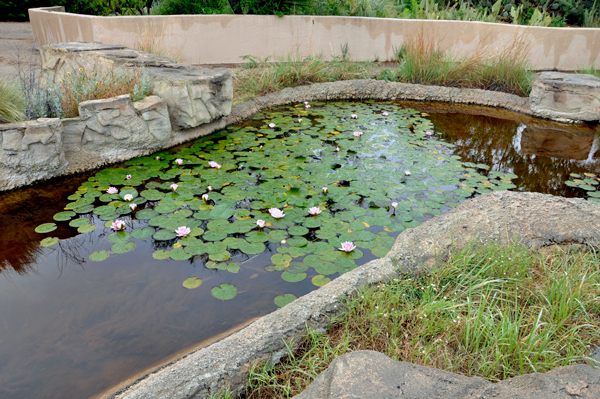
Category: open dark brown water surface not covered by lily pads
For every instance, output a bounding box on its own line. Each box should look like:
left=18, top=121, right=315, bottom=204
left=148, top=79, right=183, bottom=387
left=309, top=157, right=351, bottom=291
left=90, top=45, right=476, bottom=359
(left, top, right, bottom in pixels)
left=0, top=102, right=600, bottom=399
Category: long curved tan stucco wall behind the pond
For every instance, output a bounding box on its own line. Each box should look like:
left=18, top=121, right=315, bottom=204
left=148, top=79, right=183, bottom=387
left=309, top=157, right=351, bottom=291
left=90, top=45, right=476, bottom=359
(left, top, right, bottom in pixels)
left=29, top=8, right=600, bottom=70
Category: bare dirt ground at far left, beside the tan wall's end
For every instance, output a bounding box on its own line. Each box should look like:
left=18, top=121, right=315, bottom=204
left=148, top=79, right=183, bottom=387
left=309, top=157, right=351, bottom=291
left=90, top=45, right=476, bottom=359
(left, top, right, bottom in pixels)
left=0, top=22, right=40, bottom=79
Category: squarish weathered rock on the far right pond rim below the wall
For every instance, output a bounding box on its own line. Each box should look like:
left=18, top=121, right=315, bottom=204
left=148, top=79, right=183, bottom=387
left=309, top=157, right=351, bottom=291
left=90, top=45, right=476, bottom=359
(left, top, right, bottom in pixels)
left=529, top=72, right=600, bottom=122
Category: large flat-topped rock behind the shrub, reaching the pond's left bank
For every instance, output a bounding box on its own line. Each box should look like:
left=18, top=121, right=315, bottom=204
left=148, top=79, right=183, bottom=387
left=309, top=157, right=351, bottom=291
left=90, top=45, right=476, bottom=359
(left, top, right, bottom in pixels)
left=41, top=42, right=233, bottom=129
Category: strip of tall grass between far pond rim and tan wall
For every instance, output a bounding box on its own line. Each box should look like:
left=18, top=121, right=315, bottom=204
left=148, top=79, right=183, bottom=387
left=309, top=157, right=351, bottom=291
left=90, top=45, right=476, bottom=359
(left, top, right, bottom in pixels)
left=233, top=36, right=534, bottom=105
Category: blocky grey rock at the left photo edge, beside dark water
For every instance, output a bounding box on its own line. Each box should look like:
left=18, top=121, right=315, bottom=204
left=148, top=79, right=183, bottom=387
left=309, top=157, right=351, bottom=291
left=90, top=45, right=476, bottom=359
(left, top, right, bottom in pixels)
left=0, top=119, right=68, bottom=190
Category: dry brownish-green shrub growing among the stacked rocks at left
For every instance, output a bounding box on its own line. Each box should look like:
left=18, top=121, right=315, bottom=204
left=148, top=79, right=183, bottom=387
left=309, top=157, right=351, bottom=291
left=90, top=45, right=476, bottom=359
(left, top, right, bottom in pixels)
left=60, top=68, right=152, bottom=118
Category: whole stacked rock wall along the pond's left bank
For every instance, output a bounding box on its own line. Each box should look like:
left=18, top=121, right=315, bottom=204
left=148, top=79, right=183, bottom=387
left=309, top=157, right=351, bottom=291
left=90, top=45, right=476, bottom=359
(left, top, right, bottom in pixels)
left=0, top=43, right=233, bottom=191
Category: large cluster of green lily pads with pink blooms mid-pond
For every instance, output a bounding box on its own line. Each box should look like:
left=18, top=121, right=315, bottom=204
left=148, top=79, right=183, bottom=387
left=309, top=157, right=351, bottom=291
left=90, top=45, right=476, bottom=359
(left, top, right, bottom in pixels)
left=36, top=102, right=516, bottom=304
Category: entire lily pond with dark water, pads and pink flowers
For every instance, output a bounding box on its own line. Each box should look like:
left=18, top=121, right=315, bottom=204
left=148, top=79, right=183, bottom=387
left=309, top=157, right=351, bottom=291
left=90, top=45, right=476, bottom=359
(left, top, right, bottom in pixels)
left=0, top=101, right=600, bottom=399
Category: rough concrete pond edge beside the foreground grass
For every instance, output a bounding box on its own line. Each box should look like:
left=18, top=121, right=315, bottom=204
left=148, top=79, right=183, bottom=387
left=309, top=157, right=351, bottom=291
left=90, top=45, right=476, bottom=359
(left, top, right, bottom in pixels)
left=108, top=191, right=600, bottom=399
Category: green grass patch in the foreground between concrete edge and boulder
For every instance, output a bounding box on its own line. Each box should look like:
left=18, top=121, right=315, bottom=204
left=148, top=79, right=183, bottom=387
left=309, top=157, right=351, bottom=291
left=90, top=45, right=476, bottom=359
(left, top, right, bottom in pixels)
left=244, top=245, right=600, bottom=398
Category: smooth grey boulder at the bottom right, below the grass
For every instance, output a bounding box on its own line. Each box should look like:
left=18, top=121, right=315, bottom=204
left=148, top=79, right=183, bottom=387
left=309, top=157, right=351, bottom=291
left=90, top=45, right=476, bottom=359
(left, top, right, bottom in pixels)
left=294, top=351, right=600, bottom=399
